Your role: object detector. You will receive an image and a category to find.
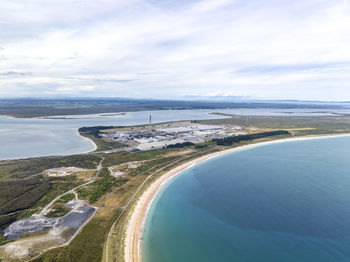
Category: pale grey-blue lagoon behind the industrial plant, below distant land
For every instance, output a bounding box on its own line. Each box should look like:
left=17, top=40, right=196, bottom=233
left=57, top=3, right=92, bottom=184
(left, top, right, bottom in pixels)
left=0, top=108, right=350, bottom=160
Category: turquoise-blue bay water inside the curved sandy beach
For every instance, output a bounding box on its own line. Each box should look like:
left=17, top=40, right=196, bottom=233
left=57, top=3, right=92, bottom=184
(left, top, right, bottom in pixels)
left=143, top=137, right=350, bottom=262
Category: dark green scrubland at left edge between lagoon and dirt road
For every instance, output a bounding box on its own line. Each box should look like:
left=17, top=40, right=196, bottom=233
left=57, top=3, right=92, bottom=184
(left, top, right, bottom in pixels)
left=0, top=155, right=100, bottom=230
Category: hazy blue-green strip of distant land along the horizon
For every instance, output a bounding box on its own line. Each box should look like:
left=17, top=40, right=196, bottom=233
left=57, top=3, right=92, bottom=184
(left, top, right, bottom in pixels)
left=0, top=97, right=342, bottom=117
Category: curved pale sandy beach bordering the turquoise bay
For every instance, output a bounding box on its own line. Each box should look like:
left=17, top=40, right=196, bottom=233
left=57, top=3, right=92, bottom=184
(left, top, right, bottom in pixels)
left=124, top=134, right=350, bottom=262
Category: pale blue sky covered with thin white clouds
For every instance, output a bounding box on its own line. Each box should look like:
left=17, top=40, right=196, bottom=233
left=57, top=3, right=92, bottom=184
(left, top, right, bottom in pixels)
left=0, top=0, right=350, bottom=100
